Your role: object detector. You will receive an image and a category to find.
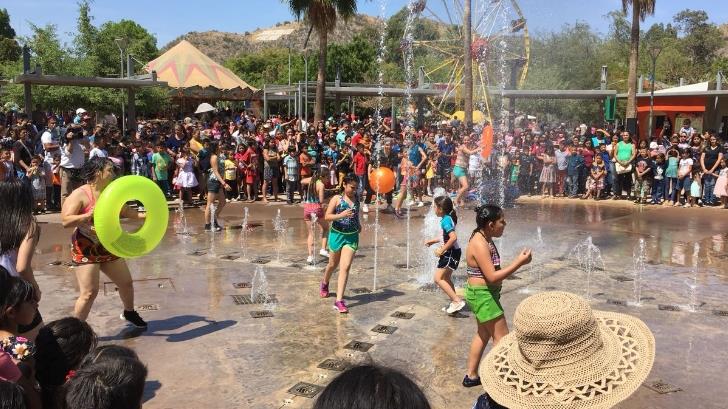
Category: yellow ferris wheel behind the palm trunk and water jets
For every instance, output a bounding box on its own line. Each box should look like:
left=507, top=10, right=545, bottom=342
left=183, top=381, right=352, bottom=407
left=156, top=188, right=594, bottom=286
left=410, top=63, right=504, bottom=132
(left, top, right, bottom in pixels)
left=412, top=0, right=531, bottom=122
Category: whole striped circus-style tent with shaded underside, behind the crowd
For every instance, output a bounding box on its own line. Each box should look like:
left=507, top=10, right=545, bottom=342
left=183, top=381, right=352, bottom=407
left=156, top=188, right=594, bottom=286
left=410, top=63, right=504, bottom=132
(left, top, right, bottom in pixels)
left=144, top=40, right=258, bottom=100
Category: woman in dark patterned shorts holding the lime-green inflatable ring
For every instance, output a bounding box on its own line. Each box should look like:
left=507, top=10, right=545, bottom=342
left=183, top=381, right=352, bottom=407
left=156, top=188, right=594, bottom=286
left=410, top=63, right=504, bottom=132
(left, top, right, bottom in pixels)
left=61, top=157, right=147, bottom=328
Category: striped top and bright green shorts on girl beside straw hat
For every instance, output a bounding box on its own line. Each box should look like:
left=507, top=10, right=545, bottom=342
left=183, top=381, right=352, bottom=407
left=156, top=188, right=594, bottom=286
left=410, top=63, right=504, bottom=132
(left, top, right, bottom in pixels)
left=465, top=233, right=503, bottom=323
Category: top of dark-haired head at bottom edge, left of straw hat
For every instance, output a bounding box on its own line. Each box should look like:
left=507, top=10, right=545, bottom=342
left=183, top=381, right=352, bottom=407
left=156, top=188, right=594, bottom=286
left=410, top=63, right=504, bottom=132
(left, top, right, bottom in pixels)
left=313, top=365, right=430, bottom=409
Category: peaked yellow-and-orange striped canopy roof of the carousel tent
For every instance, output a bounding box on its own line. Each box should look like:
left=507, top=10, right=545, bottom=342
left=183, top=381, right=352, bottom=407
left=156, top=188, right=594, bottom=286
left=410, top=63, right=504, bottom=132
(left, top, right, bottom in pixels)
left=144, top=40, right=258, bottom=93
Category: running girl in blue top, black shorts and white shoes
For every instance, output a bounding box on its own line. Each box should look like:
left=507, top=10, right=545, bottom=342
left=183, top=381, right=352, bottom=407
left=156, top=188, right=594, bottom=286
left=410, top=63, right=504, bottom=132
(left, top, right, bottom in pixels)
left=425, top=196, right=465, bottom=314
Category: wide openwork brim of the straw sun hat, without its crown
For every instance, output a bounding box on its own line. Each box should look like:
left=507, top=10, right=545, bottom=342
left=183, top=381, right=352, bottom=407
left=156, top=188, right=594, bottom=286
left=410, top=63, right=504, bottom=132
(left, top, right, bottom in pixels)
left=479, top=311, right=655, bottom=409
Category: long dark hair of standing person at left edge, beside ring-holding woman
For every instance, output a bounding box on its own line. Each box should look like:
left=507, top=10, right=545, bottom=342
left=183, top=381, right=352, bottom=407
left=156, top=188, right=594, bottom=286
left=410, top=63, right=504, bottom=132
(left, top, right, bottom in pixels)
left=0, top=179, right=39, bottom=254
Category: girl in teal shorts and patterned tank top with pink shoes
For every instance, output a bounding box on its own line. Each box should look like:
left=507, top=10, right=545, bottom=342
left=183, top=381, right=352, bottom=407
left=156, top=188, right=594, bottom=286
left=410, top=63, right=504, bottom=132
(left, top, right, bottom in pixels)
left=320, top=173, right=361, bottom=314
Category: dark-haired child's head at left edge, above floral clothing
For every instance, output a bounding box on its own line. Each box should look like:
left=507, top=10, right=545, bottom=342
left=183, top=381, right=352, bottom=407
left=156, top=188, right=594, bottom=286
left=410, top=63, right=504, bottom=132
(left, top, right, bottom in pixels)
left=0, top=267, right=38, bottom=332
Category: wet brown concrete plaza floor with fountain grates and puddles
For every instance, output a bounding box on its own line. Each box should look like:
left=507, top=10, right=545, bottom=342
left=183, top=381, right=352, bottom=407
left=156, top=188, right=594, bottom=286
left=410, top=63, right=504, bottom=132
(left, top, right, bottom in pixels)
left=34, top=199, right=728, bottom=409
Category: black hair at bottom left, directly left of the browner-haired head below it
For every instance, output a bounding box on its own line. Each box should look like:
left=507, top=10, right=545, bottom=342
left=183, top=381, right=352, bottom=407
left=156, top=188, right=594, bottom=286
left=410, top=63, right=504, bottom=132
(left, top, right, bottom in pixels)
left=35, top=317, right=96, bottom=408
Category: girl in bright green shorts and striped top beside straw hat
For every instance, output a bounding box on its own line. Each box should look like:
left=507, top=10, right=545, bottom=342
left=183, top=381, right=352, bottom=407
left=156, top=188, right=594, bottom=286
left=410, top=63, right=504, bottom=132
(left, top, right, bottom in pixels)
left=463, top=205, right=531, bottom=387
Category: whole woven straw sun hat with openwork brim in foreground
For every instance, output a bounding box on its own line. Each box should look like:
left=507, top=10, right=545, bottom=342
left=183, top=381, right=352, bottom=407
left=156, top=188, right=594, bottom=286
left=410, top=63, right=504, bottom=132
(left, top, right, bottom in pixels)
left=480, top=291, right=655, bottom=409
